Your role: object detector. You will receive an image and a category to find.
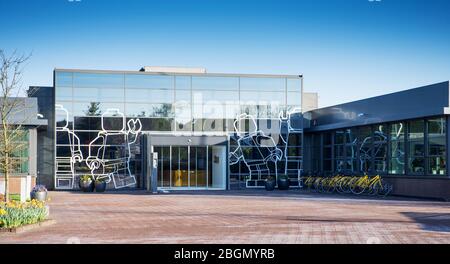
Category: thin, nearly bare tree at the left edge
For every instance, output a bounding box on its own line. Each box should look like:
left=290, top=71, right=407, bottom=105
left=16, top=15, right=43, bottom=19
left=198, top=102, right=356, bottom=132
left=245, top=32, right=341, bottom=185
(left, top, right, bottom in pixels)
left=0, top=49, right=30, bottom=202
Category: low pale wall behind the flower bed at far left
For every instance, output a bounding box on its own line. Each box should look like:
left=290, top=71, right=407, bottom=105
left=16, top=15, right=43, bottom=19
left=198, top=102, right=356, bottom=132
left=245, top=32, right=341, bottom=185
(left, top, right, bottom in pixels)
left=0, top=175, right=36, bottom=202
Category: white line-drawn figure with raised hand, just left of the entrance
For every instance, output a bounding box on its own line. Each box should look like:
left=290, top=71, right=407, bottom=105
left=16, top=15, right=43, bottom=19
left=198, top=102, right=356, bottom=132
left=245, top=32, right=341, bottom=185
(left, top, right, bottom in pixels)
left=86, top=108, right=142, bottom=189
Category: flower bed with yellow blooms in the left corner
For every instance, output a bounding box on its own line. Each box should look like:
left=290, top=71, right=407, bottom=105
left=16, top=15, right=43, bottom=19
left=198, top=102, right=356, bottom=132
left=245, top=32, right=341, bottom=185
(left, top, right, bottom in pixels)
left=0, top=200, right=48, bottom=229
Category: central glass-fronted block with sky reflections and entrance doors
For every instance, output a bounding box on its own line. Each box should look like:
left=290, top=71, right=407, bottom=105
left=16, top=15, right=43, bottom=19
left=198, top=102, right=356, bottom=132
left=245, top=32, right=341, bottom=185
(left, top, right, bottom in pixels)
left=54, top=69, right=302, bottom=189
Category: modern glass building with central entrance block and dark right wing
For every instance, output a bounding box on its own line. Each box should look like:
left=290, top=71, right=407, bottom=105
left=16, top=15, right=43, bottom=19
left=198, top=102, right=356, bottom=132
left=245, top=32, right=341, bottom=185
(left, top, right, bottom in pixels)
left=27, top=67, right=450, bottom=199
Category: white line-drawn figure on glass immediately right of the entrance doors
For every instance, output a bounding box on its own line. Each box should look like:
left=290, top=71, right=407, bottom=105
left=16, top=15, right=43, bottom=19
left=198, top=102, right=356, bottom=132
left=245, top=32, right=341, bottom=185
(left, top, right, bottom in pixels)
left=229, top=114, right=283, bottom=188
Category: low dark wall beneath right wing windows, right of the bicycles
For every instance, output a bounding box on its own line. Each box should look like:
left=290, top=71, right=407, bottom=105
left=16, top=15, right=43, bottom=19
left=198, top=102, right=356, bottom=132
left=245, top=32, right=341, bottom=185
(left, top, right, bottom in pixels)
left=383, top=176, right=450, bottom=201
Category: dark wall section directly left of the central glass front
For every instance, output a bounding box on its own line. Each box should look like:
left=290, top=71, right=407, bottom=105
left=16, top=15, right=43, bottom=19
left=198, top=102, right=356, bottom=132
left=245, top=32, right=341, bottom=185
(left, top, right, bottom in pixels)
left=28, top=87, right=55, bottom=189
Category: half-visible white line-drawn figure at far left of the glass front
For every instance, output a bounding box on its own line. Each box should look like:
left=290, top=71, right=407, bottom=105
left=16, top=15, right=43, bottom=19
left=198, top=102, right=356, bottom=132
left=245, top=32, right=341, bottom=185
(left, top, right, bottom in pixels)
left=55, top=104, right=83, bottom=189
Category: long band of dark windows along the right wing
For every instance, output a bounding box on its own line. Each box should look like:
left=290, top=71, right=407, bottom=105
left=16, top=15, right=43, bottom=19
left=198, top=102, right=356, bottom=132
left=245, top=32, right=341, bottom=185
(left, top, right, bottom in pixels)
left=309, top=117, right=447, bottom=177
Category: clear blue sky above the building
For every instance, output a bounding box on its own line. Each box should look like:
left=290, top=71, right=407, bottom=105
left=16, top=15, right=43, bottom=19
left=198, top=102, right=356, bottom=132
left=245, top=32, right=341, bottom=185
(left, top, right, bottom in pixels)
left=0, top=0, right=450, bottom=106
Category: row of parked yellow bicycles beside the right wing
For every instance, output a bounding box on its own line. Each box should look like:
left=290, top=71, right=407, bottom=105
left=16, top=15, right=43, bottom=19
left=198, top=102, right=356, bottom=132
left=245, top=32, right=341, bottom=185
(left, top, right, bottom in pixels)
left=303, top=175, right=393, bottom=196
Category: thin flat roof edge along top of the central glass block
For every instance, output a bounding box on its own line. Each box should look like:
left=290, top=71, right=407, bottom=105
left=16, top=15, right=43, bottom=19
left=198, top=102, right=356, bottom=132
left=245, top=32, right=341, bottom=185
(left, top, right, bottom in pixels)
left=54, top=68, right=303, bottom=79
